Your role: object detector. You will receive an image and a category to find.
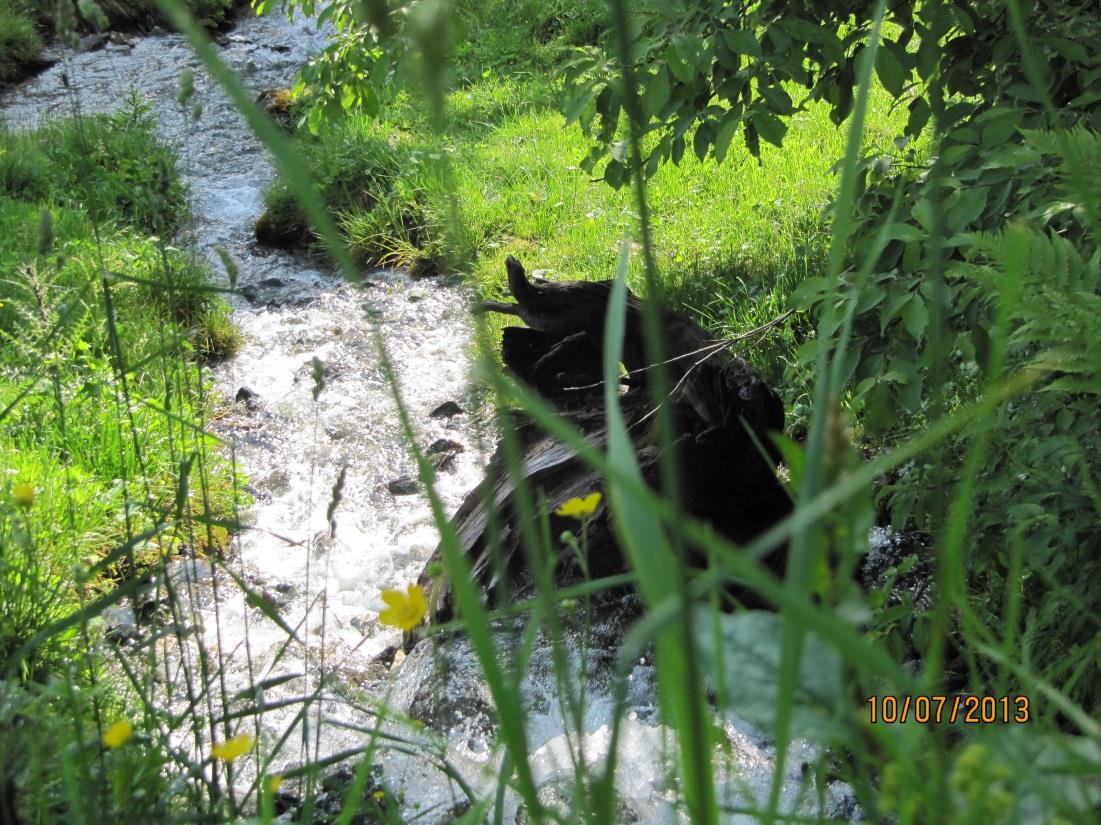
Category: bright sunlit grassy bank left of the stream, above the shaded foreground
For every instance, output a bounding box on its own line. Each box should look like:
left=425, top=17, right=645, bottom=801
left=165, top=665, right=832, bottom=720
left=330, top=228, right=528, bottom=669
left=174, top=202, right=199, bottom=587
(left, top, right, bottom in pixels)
left=0, top=106, right=237, bottom=676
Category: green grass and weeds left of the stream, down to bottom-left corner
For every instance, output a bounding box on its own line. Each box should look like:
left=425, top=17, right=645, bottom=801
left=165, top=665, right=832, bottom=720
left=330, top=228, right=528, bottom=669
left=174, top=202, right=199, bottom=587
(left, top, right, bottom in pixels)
left=0, top=93, right=237, bottom=806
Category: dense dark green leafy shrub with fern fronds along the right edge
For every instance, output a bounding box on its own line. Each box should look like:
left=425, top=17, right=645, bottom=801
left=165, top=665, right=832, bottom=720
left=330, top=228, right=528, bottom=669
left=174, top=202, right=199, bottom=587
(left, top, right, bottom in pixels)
left=796, top=3, right=1101, bottom=709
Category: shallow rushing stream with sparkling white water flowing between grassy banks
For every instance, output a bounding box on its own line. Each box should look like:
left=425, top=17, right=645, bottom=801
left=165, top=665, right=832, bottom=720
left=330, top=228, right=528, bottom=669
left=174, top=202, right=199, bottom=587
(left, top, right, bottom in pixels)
left=0, top=9, right=857, bottom=823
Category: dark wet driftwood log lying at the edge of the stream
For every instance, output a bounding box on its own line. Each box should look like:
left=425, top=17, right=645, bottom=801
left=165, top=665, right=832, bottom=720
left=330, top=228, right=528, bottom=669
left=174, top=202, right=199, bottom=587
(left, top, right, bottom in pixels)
left=421, top=257, right=791, bottom=620
